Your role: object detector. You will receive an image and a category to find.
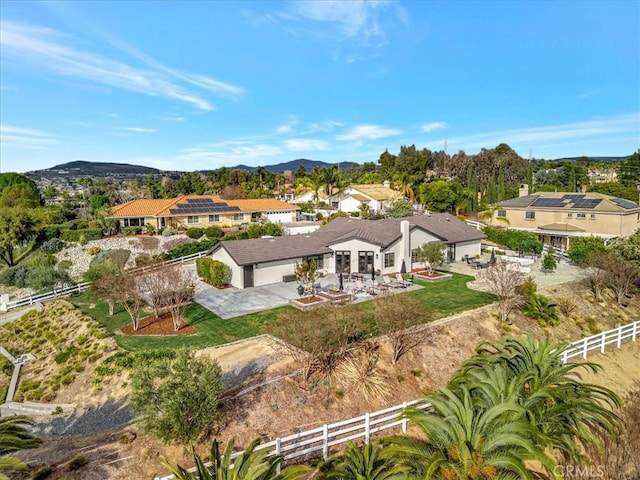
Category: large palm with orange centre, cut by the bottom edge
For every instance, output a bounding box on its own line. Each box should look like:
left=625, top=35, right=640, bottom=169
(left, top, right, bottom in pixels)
left=385, top=387, right=555, bottom=480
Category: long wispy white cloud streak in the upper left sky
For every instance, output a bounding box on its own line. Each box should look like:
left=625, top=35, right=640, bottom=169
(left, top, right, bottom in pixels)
left=0, top=21, right=244, bottom=111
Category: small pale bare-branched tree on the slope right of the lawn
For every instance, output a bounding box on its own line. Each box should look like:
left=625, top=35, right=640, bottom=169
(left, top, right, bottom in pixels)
left=477, top=261, right=526, bottom=322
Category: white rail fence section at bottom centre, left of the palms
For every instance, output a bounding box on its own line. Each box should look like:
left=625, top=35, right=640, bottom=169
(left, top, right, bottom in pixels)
left=155, top=400, right=431, bottom=480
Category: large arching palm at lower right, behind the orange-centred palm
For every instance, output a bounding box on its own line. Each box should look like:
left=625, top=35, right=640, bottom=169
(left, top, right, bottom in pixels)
left=449, top=335, right=620, bottom=462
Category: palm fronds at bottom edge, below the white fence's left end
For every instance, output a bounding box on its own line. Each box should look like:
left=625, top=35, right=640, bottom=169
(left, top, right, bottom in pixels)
left=162, top=439, right=308, bottom=480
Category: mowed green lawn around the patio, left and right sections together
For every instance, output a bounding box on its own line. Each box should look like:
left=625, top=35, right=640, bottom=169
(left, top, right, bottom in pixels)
left=69, top=273, right=495, bottom=351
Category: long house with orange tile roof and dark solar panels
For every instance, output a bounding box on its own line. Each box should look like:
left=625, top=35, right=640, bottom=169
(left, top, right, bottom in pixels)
left=111, top=195, right=300, bottom=229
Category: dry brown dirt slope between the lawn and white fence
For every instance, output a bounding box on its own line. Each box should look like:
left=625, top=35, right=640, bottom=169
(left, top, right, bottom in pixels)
left=10, top=283, right=640, bottom=480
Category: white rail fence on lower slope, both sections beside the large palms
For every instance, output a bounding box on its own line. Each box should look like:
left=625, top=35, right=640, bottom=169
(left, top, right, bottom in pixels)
left=154, top=321, right=640, bottom=480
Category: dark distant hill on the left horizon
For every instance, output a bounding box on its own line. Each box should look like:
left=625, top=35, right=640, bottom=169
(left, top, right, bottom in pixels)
left=26, top=160, right=162, bottom=178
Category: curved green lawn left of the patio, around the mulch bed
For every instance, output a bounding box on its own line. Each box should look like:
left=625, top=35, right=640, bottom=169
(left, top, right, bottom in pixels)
left=69, top=292, right=290, bottom=351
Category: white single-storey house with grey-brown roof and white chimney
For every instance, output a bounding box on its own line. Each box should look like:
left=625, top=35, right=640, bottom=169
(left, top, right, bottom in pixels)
left=211, top=213, right=485, bottom=288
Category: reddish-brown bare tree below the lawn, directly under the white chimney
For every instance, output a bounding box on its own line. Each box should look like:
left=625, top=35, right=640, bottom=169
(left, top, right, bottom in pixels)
left=374, top=295, right=433, bottom=365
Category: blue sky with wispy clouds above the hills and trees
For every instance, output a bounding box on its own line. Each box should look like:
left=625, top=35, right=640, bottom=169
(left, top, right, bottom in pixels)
left=0, top=0, right=640, bottom=172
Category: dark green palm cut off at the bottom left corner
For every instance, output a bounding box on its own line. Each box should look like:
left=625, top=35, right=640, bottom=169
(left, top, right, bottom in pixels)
left=0, top=415, right=42, bottom=480
